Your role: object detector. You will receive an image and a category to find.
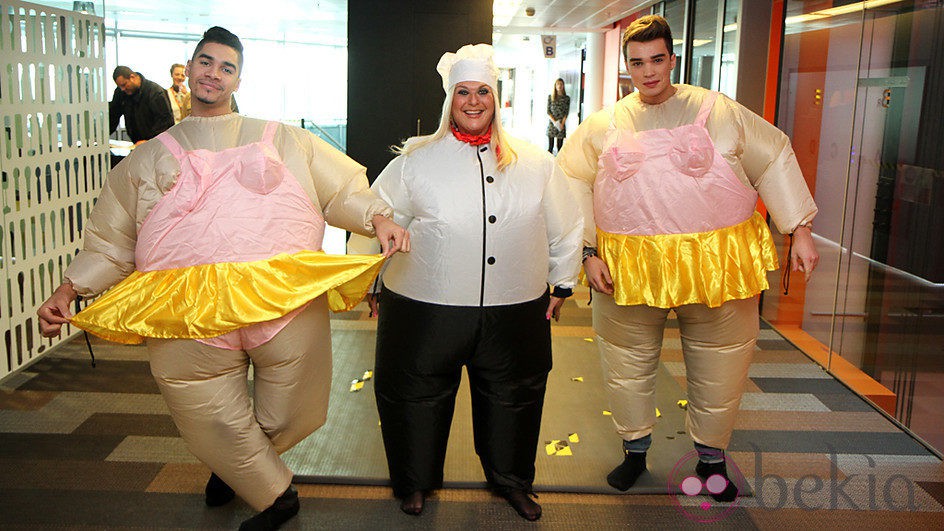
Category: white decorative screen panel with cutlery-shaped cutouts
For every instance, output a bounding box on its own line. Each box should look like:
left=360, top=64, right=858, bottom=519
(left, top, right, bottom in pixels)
left=0, top=0, right=109, bottom=378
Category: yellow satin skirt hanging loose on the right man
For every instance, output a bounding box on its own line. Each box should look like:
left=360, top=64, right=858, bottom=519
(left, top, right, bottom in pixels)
left=597, top=212, right=778, bottom=308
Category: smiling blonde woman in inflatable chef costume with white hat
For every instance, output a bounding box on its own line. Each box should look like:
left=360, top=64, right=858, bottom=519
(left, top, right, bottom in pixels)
left=350, top=44, right=581, bottom=520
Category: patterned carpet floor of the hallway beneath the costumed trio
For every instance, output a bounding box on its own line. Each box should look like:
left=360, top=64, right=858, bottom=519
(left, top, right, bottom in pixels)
left=0, top=291, right=944, bottom=529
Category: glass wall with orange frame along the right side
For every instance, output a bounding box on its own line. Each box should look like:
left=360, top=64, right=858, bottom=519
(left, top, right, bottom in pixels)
left=763, top=0, right=944, bottom=458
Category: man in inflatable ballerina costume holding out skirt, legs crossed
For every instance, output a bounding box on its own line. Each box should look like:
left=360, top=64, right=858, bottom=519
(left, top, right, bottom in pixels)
left=37, top=27, right=409, bottom=530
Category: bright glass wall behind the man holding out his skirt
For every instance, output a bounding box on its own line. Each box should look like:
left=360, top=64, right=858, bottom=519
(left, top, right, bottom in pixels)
left=41, top=0, right=347, bottom=141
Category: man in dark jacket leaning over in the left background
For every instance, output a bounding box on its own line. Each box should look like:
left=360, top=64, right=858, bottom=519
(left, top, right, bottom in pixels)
left=108, top=66, right=174, bottom=145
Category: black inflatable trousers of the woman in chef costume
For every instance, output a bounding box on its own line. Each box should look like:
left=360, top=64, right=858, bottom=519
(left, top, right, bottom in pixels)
left=374, top=289, right=551, bottom=497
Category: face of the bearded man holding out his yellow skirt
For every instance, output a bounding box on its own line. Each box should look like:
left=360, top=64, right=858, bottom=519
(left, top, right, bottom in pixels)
left=186, top=42, right=239, bottom=116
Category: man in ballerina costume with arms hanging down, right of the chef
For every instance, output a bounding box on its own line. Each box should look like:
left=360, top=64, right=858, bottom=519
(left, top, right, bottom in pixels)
left=557, top=16, right=819, bottom=501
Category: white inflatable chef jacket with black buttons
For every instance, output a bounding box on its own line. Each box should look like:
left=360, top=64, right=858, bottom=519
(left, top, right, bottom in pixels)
left=349, top=135, right=583, bottom=306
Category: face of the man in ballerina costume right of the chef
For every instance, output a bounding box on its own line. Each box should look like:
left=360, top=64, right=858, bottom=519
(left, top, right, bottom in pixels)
left=626, top=39, right=676, bottom=105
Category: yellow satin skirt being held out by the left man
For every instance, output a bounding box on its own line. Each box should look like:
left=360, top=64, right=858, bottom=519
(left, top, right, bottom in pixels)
left=72, top=251, right=383, bottom=344
